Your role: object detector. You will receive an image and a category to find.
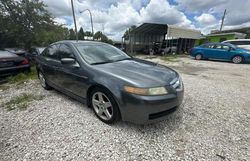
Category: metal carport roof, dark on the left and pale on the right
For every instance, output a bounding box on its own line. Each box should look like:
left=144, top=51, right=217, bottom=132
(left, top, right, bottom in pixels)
left=129, top=23, right=201, bottom=53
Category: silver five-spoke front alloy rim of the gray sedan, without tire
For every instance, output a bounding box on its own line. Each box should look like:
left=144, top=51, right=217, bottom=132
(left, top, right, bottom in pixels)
left=92, top=92, right=114, bottom=121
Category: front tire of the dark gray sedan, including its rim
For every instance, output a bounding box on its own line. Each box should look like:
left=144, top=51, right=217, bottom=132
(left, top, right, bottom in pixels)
left=90, top=88, right=120, bottom=124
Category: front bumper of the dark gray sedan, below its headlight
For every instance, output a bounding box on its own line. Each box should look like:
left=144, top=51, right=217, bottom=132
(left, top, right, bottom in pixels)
left=120, top=89, right=184, bottom=124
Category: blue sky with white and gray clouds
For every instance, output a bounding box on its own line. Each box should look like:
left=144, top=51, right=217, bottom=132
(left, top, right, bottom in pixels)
left=42, top=0, right=250, bottom=41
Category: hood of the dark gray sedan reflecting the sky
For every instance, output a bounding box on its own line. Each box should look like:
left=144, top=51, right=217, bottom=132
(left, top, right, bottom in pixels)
left=94, top=59, right=178, bottom=87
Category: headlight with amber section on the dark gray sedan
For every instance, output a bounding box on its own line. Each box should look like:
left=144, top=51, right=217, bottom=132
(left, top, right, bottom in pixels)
left=124, top=86, right=168, bottom=96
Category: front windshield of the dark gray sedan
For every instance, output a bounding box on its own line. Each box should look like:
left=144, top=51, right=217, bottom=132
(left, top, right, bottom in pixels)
left=76, top=43, right=131, bottom=65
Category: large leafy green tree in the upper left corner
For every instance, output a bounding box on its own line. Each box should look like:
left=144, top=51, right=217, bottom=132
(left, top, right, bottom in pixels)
left=0, top=0, right=55, bottom=48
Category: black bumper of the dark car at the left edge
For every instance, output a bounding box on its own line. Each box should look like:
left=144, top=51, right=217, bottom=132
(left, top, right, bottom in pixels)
left=0, top=64, right=30, bottom=77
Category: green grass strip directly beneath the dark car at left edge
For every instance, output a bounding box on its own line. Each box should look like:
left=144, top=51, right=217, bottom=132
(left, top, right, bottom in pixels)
left=8, top=66, right=37, bottom=85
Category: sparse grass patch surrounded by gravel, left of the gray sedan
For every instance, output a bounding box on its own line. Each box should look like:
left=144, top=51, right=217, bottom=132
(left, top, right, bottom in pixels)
left=3, top=93, right=44, bottom=111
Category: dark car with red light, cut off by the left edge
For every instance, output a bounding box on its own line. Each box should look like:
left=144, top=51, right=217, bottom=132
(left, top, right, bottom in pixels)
left=0, top=51, right=30, bottom=77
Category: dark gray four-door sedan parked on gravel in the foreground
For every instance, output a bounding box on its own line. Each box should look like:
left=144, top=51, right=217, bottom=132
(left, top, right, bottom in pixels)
left=36, top=41, right=184, bottom=124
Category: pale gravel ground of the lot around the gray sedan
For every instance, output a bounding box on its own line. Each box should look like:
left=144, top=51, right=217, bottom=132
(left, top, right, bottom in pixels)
left=0, top=57, right=250, bottom=161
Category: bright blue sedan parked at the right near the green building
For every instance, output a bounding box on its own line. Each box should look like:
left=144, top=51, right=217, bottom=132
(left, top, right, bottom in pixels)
left=190, top=43, right=250, bottom=64
